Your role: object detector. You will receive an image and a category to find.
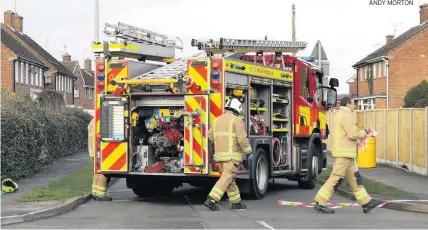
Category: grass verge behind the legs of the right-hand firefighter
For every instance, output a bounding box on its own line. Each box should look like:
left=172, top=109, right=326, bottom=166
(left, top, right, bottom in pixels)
left=320, top=166, right=410, bottom=196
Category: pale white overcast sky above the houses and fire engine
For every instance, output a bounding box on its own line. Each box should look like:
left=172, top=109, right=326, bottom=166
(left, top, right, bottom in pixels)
left=1, top=0, right=428, bottom=93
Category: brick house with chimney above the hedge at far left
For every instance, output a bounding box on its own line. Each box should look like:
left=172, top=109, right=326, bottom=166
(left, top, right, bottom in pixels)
left=1, top=10, right=75, bottom=105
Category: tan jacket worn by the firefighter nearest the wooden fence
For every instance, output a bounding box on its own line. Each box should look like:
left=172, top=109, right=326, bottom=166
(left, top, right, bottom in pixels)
left=329, top=106, right=366, bottom=158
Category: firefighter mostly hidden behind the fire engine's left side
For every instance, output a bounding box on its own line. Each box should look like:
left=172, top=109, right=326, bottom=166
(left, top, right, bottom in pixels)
left=88, top=118, right=112, bottom=201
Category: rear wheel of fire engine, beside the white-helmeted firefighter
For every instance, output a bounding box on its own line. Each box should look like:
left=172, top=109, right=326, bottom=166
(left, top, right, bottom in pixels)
left=249, top=148, right=269, bottom=200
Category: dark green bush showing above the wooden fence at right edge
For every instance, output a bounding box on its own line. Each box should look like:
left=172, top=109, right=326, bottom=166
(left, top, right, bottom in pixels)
left=404, top=80, right=428, bottom=108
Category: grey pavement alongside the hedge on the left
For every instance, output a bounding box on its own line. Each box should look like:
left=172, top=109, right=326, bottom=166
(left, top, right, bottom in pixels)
left=1, top=152, right=91, bottom=217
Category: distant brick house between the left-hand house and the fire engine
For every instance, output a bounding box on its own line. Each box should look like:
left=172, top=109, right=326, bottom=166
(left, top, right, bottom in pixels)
left=61, top=53, right=94, bottom=113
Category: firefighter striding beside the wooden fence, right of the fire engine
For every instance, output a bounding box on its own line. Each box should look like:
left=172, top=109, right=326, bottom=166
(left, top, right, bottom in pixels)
left=314, top=97, right=378, bottom=214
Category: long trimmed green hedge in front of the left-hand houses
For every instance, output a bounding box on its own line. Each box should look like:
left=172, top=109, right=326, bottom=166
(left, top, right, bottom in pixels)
left=1, top=90, right=92, bottom=179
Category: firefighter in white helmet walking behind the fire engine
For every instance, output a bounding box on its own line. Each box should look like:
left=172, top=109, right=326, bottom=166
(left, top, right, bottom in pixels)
left=204, top=97, right=252, bottom=211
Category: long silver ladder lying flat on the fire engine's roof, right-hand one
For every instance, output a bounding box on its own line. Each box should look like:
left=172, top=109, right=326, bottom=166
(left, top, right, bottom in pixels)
left=191, top=38, right=307, bottom=54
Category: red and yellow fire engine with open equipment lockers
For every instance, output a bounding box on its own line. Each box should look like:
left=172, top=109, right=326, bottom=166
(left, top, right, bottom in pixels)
left=92, top=23, right=338, bottom=199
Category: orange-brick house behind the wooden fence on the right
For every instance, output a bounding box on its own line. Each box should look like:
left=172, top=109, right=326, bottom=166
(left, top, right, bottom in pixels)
left=347, top=4, right=428, bottom=110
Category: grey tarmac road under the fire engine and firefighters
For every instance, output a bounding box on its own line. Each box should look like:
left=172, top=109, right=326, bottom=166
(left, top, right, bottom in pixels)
left=2, top=179, right=428, bottom=229
